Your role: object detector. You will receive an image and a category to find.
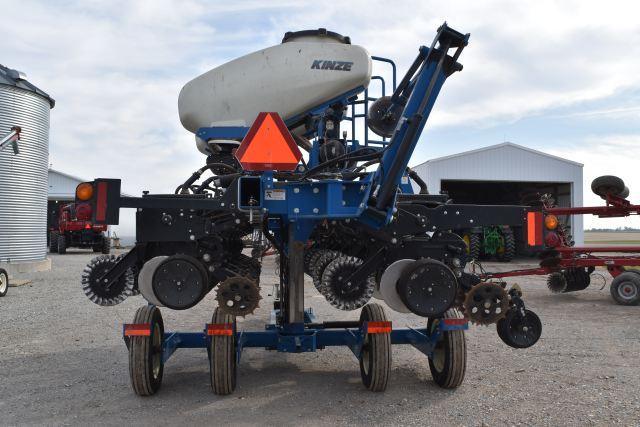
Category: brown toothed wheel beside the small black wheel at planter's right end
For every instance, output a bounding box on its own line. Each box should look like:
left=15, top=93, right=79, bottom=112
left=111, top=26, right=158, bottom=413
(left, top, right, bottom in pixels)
left=464, top=283, right=509, bottom=325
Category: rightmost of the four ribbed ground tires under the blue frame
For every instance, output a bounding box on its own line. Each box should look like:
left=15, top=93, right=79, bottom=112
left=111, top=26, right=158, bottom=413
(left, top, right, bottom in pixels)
left=427, top=308, right=467, bottom=388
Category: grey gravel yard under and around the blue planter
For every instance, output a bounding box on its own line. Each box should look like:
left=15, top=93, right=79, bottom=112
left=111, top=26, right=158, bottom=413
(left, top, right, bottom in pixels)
left=0, top=250, right=640, bottom=426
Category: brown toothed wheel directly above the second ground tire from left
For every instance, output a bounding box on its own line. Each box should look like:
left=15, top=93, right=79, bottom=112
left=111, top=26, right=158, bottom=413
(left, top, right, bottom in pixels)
left=216, top=276, right=262, bottom=316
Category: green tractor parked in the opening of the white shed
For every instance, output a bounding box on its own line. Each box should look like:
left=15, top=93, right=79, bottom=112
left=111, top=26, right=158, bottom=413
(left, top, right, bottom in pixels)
left=459, top=225, right=516, bottom=262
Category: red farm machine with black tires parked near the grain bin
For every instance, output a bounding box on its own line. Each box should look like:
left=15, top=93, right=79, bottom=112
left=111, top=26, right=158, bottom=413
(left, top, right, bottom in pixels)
left=49, top=203, right=111, bottom=254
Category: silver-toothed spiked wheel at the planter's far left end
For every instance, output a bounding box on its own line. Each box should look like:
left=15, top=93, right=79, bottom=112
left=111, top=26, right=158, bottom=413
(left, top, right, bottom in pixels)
left=82, top=255, right=134, bottom=306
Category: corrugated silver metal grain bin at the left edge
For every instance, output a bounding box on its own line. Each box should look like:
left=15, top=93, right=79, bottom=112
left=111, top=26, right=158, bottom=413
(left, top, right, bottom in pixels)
left=0, top=65, right=55, bottom=272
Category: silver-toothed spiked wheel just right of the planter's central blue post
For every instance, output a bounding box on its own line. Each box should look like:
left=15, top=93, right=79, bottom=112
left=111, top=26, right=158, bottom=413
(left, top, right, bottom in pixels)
left=322, top=255, right=376, bottom=311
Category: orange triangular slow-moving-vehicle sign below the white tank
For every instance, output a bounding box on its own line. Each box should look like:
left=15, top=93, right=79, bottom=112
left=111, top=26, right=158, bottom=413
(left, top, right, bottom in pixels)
left=236, top=113, right=302, bottom=171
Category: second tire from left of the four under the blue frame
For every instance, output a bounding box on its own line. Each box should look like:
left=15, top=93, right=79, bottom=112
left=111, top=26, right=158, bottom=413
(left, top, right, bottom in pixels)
left=209, top=308, right=238, bottom=396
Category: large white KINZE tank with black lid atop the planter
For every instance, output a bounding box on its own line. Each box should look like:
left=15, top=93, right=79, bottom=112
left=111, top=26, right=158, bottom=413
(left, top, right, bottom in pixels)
left=178, top=29, right=371, bottom=154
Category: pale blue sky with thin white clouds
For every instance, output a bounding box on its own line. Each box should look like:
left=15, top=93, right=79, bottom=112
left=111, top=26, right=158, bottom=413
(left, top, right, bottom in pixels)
left=0, top=0, right=640, bottom=234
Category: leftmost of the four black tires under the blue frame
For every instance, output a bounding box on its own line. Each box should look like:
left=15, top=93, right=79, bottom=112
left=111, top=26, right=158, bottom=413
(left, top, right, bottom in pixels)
left=129, top=305, right=164, bottom=396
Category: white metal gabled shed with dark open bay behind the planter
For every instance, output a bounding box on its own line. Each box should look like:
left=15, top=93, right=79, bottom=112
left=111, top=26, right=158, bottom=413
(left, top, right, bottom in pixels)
left=412, top=142, right=584, bottom=245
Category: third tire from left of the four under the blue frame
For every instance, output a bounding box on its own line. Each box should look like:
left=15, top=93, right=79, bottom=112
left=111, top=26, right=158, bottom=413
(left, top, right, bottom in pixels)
left=358, top=303, right=391, bottom=392
